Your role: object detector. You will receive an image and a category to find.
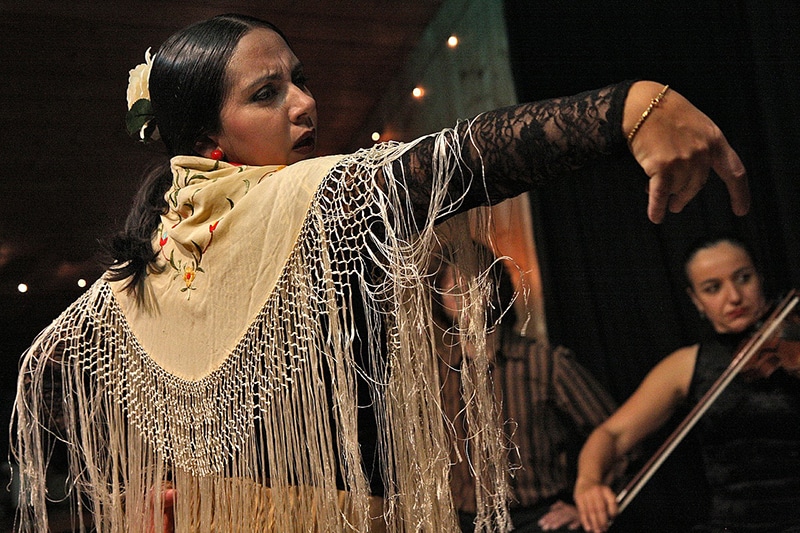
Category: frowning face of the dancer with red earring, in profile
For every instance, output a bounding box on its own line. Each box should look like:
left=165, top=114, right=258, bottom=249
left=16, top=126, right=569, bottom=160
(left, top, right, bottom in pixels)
left=205, top=28, right=317, bottom=165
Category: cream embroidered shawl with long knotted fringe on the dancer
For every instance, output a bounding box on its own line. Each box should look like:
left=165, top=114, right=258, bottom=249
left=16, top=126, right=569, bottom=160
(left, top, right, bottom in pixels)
left=14, top=138, right=510, bottom=533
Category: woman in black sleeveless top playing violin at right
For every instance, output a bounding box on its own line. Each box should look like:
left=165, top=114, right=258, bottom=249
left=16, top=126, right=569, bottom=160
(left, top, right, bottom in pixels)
left=575, top=236, right=800, bottom=533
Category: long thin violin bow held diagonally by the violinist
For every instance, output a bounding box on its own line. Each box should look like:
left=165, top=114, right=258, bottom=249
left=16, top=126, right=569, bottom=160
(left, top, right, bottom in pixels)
left=617, top=289, right=800, bottom=513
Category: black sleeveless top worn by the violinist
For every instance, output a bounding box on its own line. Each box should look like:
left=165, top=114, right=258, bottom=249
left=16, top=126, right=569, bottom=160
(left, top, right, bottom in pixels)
left=689, top=328, right=800, bottom=533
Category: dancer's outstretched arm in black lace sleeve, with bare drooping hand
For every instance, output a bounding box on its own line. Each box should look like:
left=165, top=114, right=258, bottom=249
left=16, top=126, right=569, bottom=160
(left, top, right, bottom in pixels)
left=404, top=81, right=750, bottom=222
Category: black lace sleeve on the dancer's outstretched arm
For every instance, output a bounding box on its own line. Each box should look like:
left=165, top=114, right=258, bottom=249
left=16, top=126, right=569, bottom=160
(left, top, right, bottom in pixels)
left=401, top=81, right=633, bottom=221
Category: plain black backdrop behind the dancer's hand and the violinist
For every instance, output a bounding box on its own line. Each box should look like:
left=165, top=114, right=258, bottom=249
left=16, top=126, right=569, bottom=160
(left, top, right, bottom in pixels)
left=506, top=0, right=800, bottom=532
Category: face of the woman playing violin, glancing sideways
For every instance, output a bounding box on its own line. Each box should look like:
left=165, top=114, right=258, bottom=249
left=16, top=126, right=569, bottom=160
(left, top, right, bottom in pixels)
left=686, top=241, right=767, bottom=333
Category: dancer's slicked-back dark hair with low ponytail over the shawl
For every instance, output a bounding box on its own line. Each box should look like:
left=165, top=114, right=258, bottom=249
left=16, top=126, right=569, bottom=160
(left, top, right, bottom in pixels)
left=104, top=14, right=289, bottom=292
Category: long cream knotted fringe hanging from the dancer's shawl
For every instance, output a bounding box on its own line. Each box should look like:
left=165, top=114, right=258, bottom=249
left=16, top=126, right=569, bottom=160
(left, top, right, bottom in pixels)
left=12, top=127, right=510, bottom=533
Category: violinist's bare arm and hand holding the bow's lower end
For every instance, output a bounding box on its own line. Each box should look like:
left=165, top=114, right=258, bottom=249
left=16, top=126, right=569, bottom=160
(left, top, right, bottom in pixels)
left=575, top=345, right=697, bottom=532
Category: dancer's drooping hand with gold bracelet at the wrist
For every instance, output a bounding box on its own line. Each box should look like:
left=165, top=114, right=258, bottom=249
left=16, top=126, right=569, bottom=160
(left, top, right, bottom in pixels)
left=623, top=81, right=750, bottom=223
